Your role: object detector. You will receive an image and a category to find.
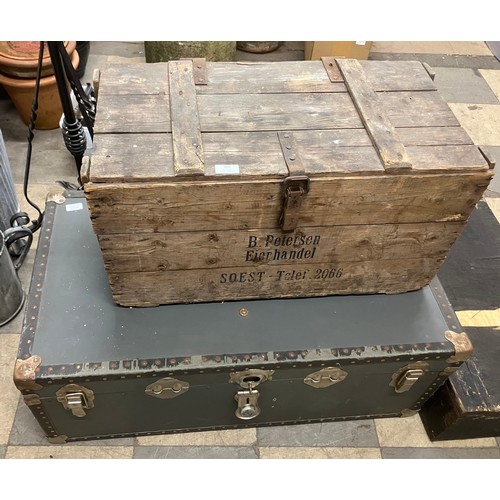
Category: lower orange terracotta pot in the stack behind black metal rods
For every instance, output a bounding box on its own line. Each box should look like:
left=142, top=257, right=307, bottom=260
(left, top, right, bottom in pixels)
left=0, top=50, right=80, bottom=130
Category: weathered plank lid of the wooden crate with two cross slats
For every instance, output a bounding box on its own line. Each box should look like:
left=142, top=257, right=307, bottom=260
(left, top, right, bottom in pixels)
left=90, top=58, right=488, bottom=182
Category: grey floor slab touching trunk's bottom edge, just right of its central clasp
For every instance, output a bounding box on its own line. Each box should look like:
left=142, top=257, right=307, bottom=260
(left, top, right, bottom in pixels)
left=257, top=420, right=378, bottom=448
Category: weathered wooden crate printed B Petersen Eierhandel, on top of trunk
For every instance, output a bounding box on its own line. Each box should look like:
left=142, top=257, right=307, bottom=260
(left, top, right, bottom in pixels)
left=83, top=58, right=492, bottom=306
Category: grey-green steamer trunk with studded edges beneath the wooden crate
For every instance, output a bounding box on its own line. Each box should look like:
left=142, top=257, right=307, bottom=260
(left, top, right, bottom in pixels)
left=14, top=192, right=472, bottom=443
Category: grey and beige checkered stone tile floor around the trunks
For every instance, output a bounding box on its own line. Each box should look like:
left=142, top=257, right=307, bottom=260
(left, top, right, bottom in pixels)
left=0, top=42, right=500, bottom=460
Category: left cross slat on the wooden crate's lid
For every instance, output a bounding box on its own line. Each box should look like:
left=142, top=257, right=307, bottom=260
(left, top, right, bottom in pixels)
left=168, top=60, right=205, bottom=175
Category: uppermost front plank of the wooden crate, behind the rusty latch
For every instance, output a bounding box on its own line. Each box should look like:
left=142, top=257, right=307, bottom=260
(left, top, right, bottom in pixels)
left=85, top=172, right=491, bottom=234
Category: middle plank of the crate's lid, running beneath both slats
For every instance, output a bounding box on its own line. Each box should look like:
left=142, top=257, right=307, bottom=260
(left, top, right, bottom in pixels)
left=95, top=92, right=460, bottom=134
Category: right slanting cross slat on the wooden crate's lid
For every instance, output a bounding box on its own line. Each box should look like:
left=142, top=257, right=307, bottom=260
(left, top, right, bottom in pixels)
left=337, top=59, right=411, bottom=173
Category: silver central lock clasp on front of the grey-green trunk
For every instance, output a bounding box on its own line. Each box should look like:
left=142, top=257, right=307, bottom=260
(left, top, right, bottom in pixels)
left=229, top=368, right=274, bottom=420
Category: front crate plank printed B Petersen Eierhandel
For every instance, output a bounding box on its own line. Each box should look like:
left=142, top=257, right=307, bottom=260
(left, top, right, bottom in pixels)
left=99, top=222, right=464, bottom=273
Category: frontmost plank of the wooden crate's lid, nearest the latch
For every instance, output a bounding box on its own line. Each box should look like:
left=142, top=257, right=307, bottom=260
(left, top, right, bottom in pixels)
left=90, top=127, right=485, bottom=182
